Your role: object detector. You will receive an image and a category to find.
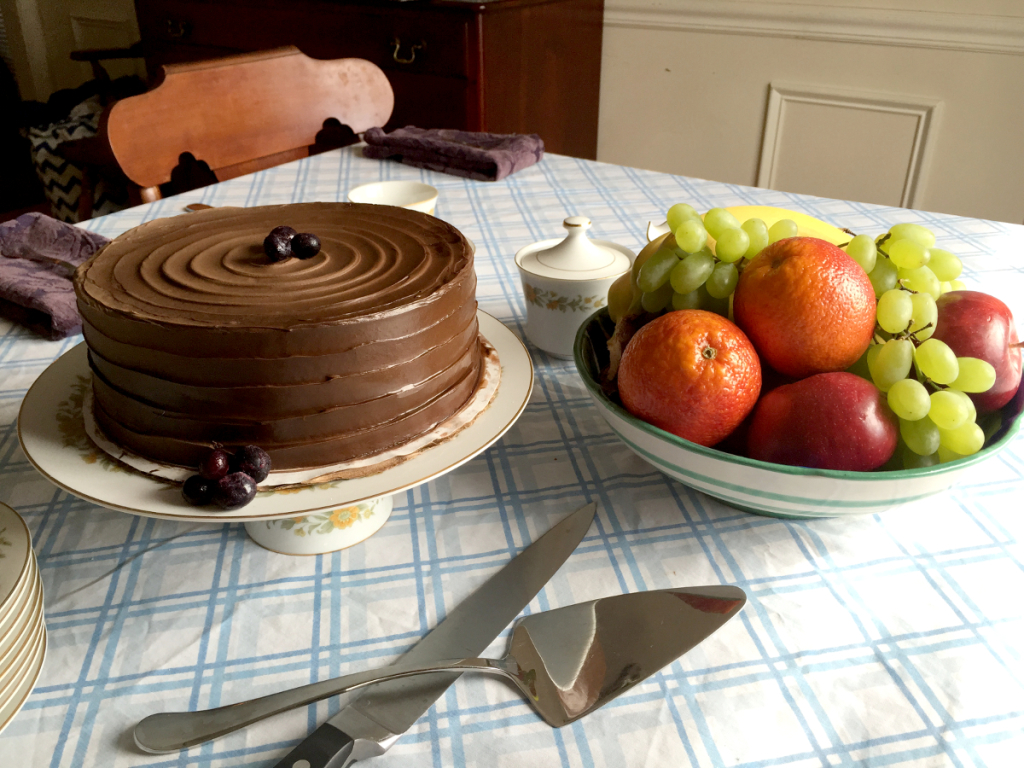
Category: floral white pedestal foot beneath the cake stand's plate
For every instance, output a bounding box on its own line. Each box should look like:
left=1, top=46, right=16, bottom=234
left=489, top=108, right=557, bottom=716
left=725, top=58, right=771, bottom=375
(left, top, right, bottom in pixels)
left=246, top=496, right=394, bottom=555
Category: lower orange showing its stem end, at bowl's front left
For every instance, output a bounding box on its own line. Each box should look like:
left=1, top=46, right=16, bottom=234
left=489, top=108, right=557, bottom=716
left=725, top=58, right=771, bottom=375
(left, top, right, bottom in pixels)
left=618, top=309, right=761, bottom=446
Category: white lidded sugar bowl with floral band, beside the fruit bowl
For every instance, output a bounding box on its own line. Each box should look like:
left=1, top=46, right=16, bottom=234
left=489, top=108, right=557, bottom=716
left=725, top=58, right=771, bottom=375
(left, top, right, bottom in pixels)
left=515, top=216, right=636, bottom=359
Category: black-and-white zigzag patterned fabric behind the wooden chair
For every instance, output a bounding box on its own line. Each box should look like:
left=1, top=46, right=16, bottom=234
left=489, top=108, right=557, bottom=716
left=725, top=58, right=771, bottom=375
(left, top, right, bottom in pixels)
left=25, top=96, right=128, bottom=222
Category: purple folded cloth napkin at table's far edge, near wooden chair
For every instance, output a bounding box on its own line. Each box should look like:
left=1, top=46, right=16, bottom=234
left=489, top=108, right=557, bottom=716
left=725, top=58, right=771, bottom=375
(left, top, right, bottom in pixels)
left=362, top=126, right=544, bottom=181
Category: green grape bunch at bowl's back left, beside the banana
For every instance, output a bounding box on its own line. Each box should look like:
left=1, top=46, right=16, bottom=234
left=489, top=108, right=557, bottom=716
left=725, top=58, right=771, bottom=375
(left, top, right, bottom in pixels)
left=637, top=203, right=797, bottom=316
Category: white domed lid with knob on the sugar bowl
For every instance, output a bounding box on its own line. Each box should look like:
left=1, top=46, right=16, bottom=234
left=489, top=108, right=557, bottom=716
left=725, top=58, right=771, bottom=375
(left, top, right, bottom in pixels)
left=515, top=216, right=636, bottom=281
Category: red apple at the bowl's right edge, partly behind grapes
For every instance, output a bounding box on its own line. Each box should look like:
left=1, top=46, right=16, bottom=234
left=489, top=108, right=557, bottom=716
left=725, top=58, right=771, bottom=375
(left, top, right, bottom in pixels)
left=932, top=291, right=1021, bottom=414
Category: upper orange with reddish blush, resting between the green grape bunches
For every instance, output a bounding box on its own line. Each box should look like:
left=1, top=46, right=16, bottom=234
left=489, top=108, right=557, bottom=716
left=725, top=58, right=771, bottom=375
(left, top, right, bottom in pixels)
left=733, top=238, right=876, bottom=379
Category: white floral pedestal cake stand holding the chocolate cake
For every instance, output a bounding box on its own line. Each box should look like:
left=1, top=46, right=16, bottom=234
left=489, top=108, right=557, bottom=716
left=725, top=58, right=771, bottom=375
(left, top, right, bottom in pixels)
left=17, top=312, right=534, bottom=555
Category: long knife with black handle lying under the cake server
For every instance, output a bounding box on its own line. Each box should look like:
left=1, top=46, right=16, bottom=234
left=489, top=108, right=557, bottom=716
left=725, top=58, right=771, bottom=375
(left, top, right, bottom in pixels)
left=275, top=502, right=597, bottom=768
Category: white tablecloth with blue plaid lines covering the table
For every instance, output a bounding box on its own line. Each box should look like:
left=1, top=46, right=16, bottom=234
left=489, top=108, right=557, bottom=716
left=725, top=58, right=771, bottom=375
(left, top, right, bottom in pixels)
left=0, top=147, right=1024, bottom=768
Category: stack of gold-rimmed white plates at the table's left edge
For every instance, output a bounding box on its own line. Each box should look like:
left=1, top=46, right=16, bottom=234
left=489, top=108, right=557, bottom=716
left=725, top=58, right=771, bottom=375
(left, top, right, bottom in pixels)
left=0, top=504, right=46, bottom=730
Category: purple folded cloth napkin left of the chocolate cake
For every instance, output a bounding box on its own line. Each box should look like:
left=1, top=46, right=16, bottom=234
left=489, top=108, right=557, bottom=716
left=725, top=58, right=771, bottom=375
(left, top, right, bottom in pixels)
left=0, top=213, right=110, bottom=339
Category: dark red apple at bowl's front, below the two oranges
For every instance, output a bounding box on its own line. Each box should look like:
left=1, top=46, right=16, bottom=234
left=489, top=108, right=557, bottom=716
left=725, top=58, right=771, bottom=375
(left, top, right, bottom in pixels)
left=746, top=371, right=899, bottom=472
